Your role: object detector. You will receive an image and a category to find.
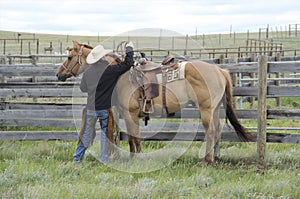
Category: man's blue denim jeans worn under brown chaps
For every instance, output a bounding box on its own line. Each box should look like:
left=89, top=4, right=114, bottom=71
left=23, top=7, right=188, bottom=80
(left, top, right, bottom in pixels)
left=74, top=109, right=109, bottom=164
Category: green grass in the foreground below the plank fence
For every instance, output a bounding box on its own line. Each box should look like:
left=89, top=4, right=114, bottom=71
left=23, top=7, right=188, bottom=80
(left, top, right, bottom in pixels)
left=0, top=141, right=300, bottom=198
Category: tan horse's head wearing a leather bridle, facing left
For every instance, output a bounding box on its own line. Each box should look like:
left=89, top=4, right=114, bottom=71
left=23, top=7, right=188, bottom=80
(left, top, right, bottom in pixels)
left=56, top=41, right=93, bottom=81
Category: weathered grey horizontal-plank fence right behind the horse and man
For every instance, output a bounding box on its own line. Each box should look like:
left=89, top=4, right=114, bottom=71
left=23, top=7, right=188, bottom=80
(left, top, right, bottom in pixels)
left=0, top=58, right=300, bottom=143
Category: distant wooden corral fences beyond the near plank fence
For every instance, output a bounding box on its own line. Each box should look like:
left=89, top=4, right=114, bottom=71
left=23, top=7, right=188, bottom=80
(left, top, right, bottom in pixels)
left=0, top=46, right=300, bottom=65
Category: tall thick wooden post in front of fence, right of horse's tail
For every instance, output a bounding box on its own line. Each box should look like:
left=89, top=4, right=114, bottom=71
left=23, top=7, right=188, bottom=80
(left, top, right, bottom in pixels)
left=257, top=55, right=268, bottom=169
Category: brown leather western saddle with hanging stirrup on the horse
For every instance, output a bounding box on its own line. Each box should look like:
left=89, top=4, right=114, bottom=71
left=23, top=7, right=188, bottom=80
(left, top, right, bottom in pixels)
left=130, top=56, right=178, bottom=125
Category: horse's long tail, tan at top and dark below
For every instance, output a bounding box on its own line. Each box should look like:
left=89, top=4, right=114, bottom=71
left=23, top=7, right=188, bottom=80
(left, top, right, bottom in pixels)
left=221, top=69, right=253, bottom=142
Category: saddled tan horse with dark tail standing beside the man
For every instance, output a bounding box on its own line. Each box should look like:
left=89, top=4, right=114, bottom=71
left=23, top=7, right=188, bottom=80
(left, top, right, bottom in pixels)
left=57, top=41, right=252, bottom=164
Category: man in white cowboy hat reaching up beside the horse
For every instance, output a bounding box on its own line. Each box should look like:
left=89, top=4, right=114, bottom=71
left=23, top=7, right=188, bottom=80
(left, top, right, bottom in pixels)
left=74, top=42, right=134, bottom=164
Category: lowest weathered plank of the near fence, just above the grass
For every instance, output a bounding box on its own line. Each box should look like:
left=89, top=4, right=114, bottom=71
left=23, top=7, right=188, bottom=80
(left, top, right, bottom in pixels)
left=0, top=131, right=300, bottom=144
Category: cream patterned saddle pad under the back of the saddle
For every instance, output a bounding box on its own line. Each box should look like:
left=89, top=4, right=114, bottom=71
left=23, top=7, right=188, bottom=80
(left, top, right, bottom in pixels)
left=156, top=62, right=187, bottom=84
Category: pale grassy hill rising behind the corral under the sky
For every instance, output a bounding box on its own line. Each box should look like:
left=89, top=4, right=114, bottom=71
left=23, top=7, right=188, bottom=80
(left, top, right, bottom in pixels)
left=0, top=29, right=300, bottom=59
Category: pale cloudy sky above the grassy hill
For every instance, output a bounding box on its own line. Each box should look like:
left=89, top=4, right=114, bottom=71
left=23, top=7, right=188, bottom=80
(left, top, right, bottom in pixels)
left=0, top=0, right=300, bottom=36
